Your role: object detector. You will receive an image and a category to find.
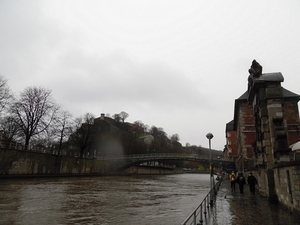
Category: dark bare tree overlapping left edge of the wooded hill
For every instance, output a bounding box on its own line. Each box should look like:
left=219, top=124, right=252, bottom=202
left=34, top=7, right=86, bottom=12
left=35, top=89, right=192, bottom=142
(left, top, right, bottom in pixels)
left=70, top=113, right=95, bottom=157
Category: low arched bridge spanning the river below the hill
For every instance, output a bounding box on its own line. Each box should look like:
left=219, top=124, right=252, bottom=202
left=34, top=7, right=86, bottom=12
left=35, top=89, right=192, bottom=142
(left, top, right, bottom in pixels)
left=101, top=153, right=234, bottom=171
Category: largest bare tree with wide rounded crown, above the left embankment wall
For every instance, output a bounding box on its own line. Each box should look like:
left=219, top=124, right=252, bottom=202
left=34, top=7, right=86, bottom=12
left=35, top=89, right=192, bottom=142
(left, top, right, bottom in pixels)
left=11, top=87, right=58, bottom=149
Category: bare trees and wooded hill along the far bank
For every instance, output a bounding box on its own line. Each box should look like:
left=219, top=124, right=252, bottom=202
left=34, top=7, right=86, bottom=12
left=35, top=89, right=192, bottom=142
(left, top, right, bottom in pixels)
left=0, top=76, right=199, bottom=163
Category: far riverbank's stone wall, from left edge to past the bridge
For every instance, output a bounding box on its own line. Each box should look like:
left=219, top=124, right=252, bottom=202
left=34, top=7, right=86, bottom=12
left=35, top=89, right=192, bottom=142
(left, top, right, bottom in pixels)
left=0, top=149, right=193, bottom=178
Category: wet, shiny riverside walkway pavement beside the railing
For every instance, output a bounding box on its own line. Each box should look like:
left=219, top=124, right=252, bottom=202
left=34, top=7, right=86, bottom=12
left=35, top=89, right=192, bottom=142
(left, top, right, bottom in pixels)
left=203, top=179, right=300, bottom=225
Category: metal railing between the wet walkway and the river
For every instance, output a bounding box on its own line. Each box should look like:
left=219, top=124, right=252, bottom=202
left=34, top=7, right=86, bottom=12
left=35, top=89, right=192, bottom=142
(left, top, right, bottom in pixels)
left=181, top=177, right=223, bottom=225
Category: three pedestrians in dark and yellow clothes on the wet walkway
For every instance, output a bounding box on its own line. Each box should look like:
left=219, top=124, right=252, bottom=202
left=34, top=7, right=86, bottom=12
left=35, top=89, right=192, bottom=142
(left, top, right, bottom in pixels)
left=229, top=171, right=258, bottom=194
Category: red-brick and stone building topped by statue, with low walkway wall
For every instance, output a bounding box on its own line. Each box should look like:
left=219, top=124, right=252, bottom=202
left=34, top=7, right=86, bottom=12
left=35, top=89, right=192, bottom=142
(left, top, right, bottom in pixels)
left=234, top=60, right=300, bottom=211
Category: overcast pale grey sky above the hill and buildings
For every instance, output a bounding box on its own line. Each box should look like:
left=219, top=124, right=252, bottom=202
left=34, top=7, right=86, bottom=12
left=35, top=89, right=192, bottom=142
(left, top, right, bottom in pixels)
left=0, top=0, right=300, bottom=150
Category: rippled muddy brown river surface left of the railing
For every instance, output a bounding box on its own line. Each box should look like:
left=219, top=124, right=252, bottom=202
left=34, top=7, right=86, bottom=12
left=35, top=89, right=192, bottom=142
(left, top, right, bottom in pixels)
left=0, top=174, right=209, bottom=225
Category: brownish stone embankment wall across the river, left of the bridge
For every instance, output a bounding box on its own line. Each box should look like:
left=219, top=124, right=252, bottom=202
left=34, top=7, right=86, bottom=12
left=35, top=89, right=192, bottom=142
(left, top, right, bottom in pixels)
left=0, top=149, right=109, bottom=177
